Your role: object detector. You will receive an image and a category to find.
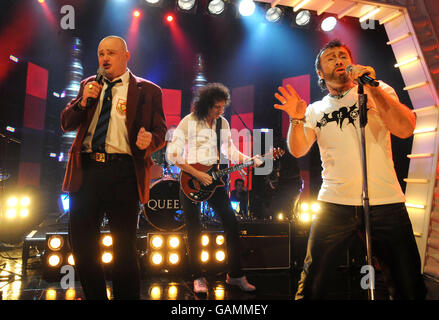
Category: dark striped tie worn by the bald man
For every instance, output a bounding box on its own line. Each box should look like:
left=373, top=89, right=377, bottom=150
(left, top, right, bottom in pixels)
left=92, top=79, right=122, bottom=152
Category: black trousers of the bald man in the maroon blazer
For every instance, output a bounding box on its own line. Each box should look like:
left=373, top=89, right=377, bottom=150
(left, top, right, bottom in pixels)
left=69, top=155, right=140, bottom=300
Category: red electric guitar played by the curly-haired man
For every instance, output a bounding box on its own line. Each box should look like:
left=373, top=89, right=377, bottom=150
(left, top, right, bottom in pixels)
left=180, top=148, right=285, bottom=202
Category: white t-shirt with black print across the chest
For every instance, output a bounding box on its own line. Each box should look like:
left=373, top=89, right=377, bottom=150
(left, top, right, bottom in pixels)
left=305, top=81, right=405, bottom=206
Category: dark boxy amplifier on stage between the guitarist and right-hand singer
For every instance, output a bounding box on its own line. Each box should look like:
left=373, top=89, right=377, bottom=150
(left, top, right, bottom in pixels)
left=240, top=220, right=291, bottom=270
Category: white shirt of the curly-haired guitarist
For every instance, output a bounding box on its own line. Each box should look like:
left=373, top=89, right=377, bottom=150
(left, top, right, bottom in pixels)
left=166, top=113, right=250, bottom=165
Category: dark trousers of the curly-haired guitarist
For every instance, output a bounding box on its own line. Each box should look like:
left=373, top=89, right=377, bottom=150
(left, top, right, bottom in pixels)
left=180, top=187, right=243, bottom=279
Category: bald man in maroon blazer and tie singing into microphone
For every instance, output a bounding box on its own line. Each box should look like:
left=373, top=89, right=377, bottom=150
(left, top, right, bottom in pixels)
left=61, top=36, right=166, bottom=299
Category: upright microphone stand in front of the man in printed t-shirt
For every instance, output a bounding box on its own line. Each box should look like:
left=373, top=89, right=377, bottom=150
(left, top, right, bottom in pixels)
left=358, top=81, right=375, bottom=300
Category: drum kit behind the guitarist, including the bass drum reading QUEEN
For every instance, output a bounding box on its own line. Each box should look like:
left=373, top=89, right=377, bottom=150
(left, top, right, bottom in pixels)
left=138, top=148, right=220, bottom=232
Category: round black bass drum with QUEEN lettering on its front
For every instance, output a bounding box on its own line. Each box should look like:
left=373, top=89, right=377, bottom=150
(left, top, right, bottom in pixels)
left=143, top=177, right=184, bottom=232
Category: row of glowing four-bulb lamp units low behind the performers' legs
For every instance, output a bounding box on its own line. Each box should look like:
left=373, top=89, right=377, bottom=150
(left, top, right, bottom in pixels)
left=44, top=232, right=227, bottom=278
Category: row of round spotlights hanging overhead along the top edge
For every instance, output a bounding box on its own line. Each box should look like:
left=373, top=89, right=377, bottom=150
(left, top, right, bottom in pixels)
left=139, top=0, right=337, bottom=32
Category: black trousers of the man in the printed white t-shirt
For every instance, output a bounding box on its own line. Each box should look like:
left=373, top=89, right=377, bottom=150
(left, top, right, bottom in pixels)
left=296, top=202, right=426, bottom=299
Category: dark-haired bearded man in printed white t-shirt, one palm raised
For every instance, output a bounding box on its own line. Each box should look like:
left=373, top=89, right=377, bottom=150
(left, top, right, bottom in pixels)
left=274, top=40, right=425, bottom=299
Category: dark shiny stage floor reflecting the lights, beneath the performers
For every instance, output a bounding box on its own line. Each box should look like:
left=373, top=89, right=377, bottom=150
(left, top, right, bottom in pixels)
left=0, top=212, right=439, bottom=301
